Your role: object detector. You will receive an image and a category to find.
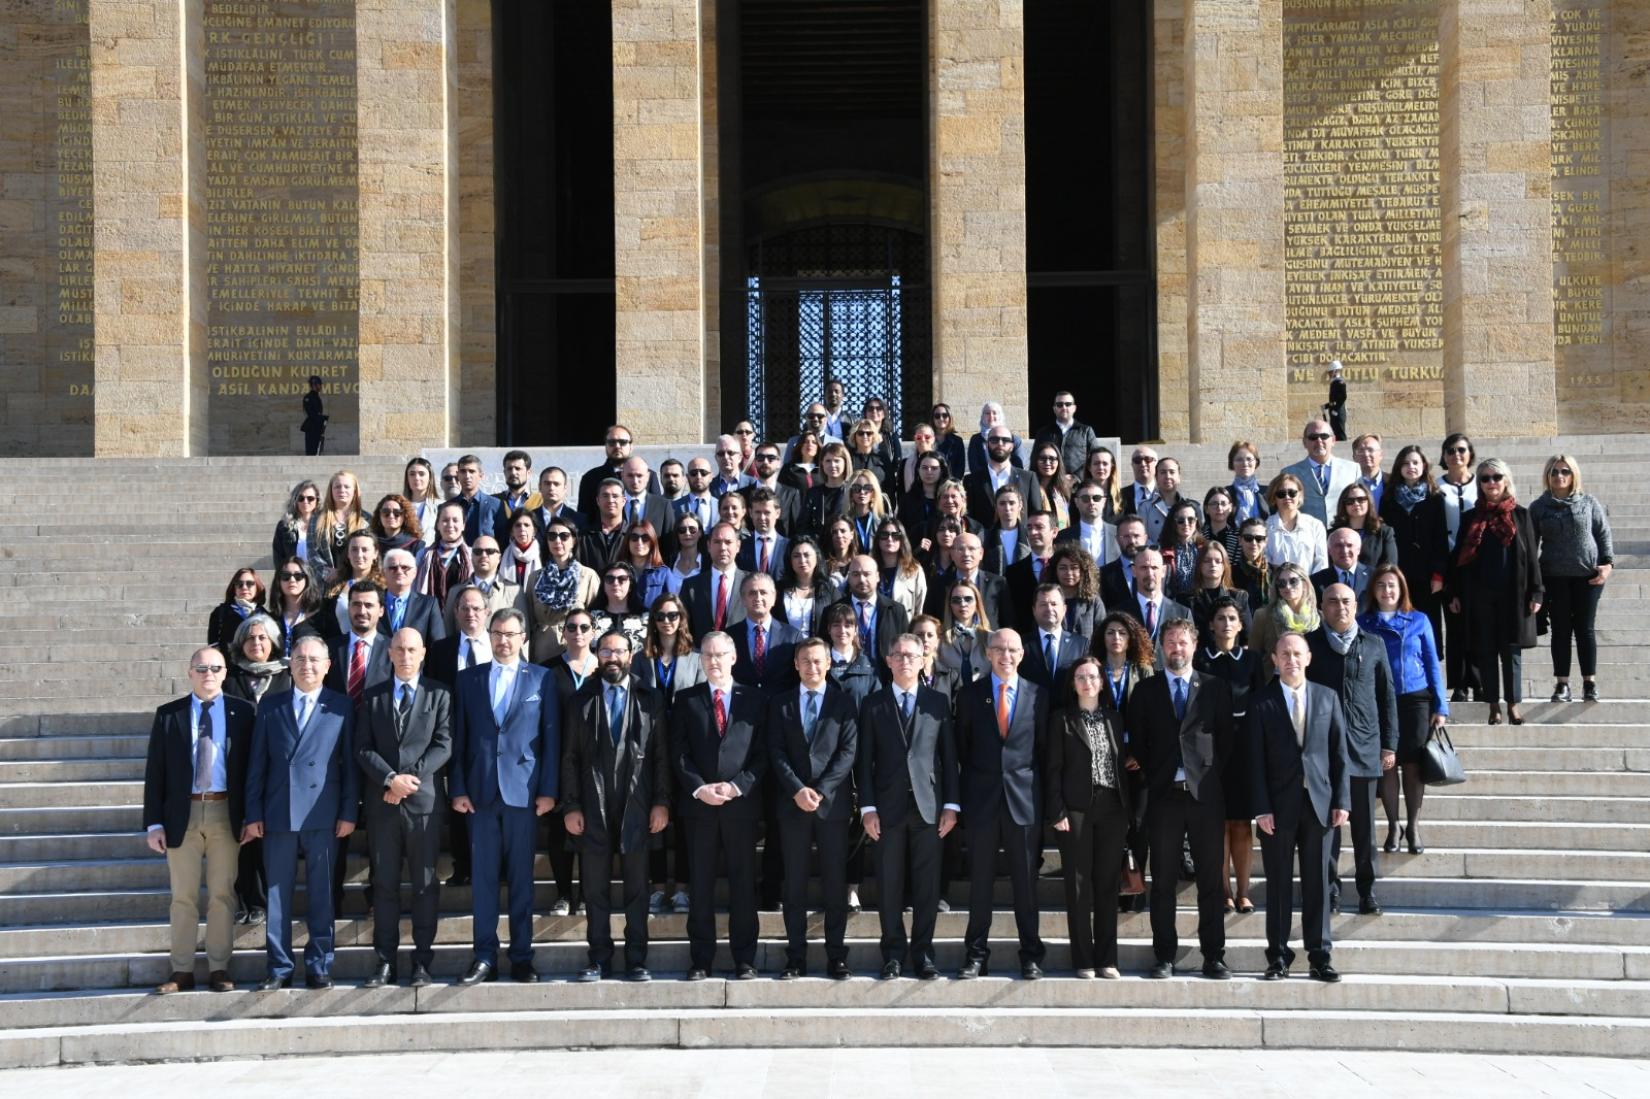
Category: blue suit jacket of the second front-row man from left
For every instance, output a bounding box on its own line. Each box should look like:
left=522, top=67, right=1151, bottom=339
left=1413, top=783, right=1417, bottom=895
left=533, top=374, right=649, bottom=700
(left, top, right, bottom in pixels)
left=246, top=686, right=361, bottom=832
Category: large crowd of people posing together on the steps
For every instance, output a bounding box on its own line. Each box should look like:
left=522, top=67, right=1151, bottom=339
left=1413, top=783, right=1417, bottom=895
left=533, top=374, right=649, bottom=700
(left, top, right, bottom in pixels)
left=144, top=396, right=1610, bottom=992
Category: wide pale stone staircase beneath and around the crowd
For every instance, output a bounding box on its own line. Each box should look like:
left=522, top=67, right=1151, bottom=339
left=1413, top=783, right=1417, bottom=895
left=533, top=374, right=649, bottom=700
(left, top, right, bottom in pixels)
left=0, top=436, right=1650, bottom=1066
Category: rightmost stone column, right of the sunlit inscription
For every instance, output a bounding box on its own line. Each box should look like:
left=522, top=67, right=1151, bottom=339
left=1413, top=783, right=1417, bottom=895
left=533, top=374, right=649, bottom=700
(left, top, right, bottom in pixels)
left=1439, top=0, right=1558, bottom=436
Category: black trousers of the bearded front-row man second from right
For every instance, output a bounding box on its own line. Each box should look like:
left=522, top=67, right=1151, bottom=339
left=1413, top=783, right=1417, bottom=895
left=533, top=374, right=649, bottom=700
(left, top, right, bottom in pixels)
left=1145, top=790, right=1226, bottom=962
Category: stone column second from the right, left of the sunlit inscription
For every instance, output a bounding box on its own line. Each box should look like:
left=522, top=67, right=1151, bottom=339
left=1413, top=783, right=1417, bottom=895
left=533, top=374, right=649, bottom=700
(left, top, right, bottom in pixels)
left=1185, top=0, right=1295, bottom=442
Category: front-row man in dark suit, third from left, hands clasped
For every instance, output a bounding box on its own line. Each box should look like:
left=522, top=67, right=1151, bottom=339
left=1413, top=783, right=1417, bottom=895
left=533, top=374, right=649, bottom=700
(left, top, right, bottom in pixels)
left=355, top=625, right=452, bottom=988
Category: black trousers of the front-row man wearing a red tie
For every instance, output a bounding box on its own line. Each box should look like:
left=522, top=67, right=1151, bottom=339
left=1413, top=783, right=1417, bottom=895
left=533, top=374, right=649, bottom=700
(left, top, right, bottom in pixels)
left=685, top=807, right=759, bottom=970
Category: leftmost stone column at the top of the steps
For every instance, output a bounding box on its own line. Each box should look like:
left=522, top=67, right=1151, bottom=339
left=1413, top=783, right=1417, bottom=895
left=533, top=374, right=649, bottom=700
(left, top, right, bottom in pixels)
left=87, top=0, right=210, bottom=457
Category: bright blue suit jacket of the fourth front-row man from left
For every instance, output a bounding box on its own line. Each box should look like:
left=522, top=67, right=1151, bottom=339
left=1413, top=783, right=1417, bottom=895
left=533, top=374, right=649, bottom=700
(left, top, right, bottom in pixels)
left=447, top=660, right=561, bottom=809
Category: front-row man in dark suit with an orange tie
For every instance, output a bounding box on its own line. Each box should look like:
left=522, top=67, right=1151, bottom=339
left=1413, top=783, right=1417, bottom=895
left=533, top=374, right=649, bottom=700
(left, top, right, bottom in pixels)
left=957, top=630, right=1049, bottom=980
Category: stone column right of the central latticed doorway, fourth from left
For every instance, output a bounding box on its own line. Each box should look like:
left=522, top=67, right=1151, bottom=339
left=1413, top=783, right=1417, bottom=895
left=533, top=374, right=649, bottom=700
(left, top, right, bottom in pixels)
left=930, top=0, right=1030, bottom=431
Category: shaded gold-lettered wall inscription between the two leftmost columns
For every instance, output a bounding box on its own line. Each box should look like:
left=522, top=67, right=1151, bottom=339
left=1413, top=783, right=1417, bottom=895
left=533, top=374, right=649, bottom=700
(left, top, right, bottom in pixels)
left=205, top=0, right=360, bottom=454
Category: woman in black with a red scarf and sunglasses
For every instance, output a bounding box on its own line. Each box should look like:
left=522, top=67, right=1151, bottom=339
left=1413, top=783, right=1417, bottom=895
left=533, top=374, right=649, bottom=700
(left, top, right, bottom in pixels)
left=1447, top=459, right=1546, bottom=724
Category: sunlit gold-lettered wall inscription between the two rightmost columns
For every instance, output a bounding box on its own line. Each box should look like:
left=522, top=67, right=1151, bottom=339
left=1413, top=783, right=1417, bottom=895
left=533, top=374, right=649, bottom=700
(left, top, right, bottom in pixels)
left=1284, top=0, right=1444, bottom=408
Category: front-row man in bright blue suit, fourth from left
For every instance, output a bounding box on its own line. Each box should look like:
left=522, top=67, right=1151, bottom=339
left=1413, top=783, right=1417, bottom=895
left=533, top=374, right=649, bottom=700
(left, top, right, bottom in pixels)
left=447, top=607, right=561, bottom=985
